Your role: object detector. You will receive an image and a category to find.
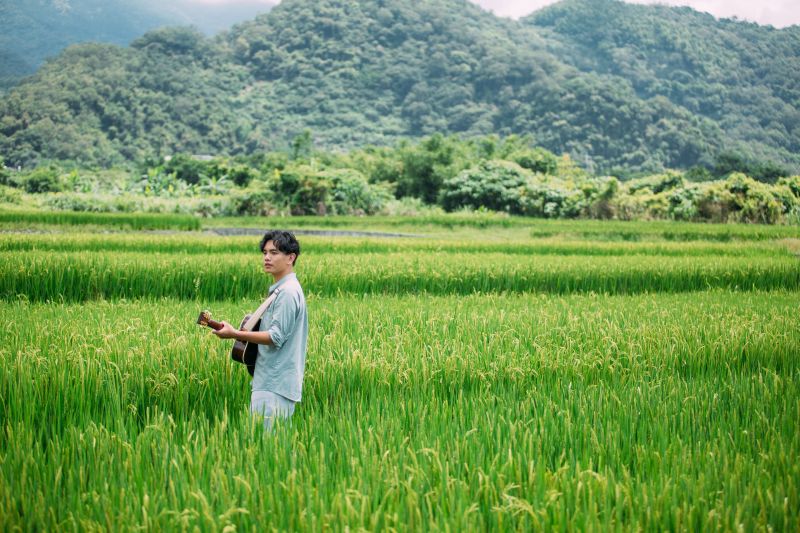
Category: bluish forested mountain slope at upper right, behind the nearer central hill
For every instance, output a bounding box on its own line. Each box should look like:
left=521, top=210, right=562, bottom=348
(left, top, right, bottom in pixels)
left=522, top=0, right=800, bottom=175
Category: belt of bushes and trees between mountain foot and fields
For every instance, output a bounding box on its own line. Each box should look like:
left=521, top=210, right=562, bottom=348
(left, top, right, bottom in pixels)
left=0, top=132, right=800, bottom=224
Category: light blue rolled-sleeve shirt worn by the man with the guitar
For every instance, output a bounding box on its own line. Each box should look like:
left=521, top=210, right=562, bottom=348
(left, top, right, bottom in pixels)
left=252, top=272, right=308, bottom=402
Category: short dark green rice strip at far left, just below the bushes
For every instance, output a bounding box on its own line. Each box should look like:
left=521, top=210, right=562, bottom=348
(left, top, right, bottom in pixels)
left=0, top=210, right=200, bottom=230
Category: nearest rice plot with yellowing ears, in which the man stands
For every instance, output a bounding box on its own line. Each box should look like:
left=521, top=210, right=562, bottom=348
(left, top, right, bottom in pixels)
left=0, top=291, right=800, bottom=531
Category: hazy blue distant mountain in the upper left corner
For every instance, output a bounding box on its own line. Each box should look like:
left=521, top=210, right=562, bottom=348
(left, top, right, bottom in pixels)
left=0, top=0, right=269, bottom=91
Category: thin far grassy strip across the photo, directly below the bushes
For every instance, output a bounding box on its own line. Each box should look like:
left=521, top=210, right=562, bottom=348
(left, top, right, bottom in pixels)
left=0, top=208, right=800, bottom=242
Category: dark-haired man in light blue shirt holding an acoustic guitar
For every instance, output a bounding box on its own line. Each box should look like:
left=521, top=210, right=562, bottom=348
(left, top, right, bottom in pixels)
left=214, top=231, right=308, bottom=429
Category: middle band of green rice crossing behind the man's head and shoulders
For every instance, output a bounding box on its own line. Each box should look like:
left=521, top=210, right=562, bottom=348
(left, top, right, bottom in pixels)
left=0, top=251, right=800, bottom=301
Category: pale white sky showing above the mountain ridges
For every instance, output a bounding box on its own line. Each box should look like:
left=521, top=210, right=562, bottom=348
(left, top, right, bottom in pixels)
left=186, top=0, right=800, bottom=28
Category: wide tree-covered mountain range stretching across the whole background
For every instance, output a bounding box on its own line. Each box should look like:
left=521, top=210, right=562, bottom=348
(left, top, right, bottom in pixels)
left=0, top=0, right=800, bottom=172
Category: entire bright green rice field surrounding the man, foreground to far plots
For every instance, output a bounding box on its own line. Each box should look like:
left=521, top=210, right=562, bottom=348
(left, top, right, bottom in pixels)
left=0, top=214, right=800, bottom=531
